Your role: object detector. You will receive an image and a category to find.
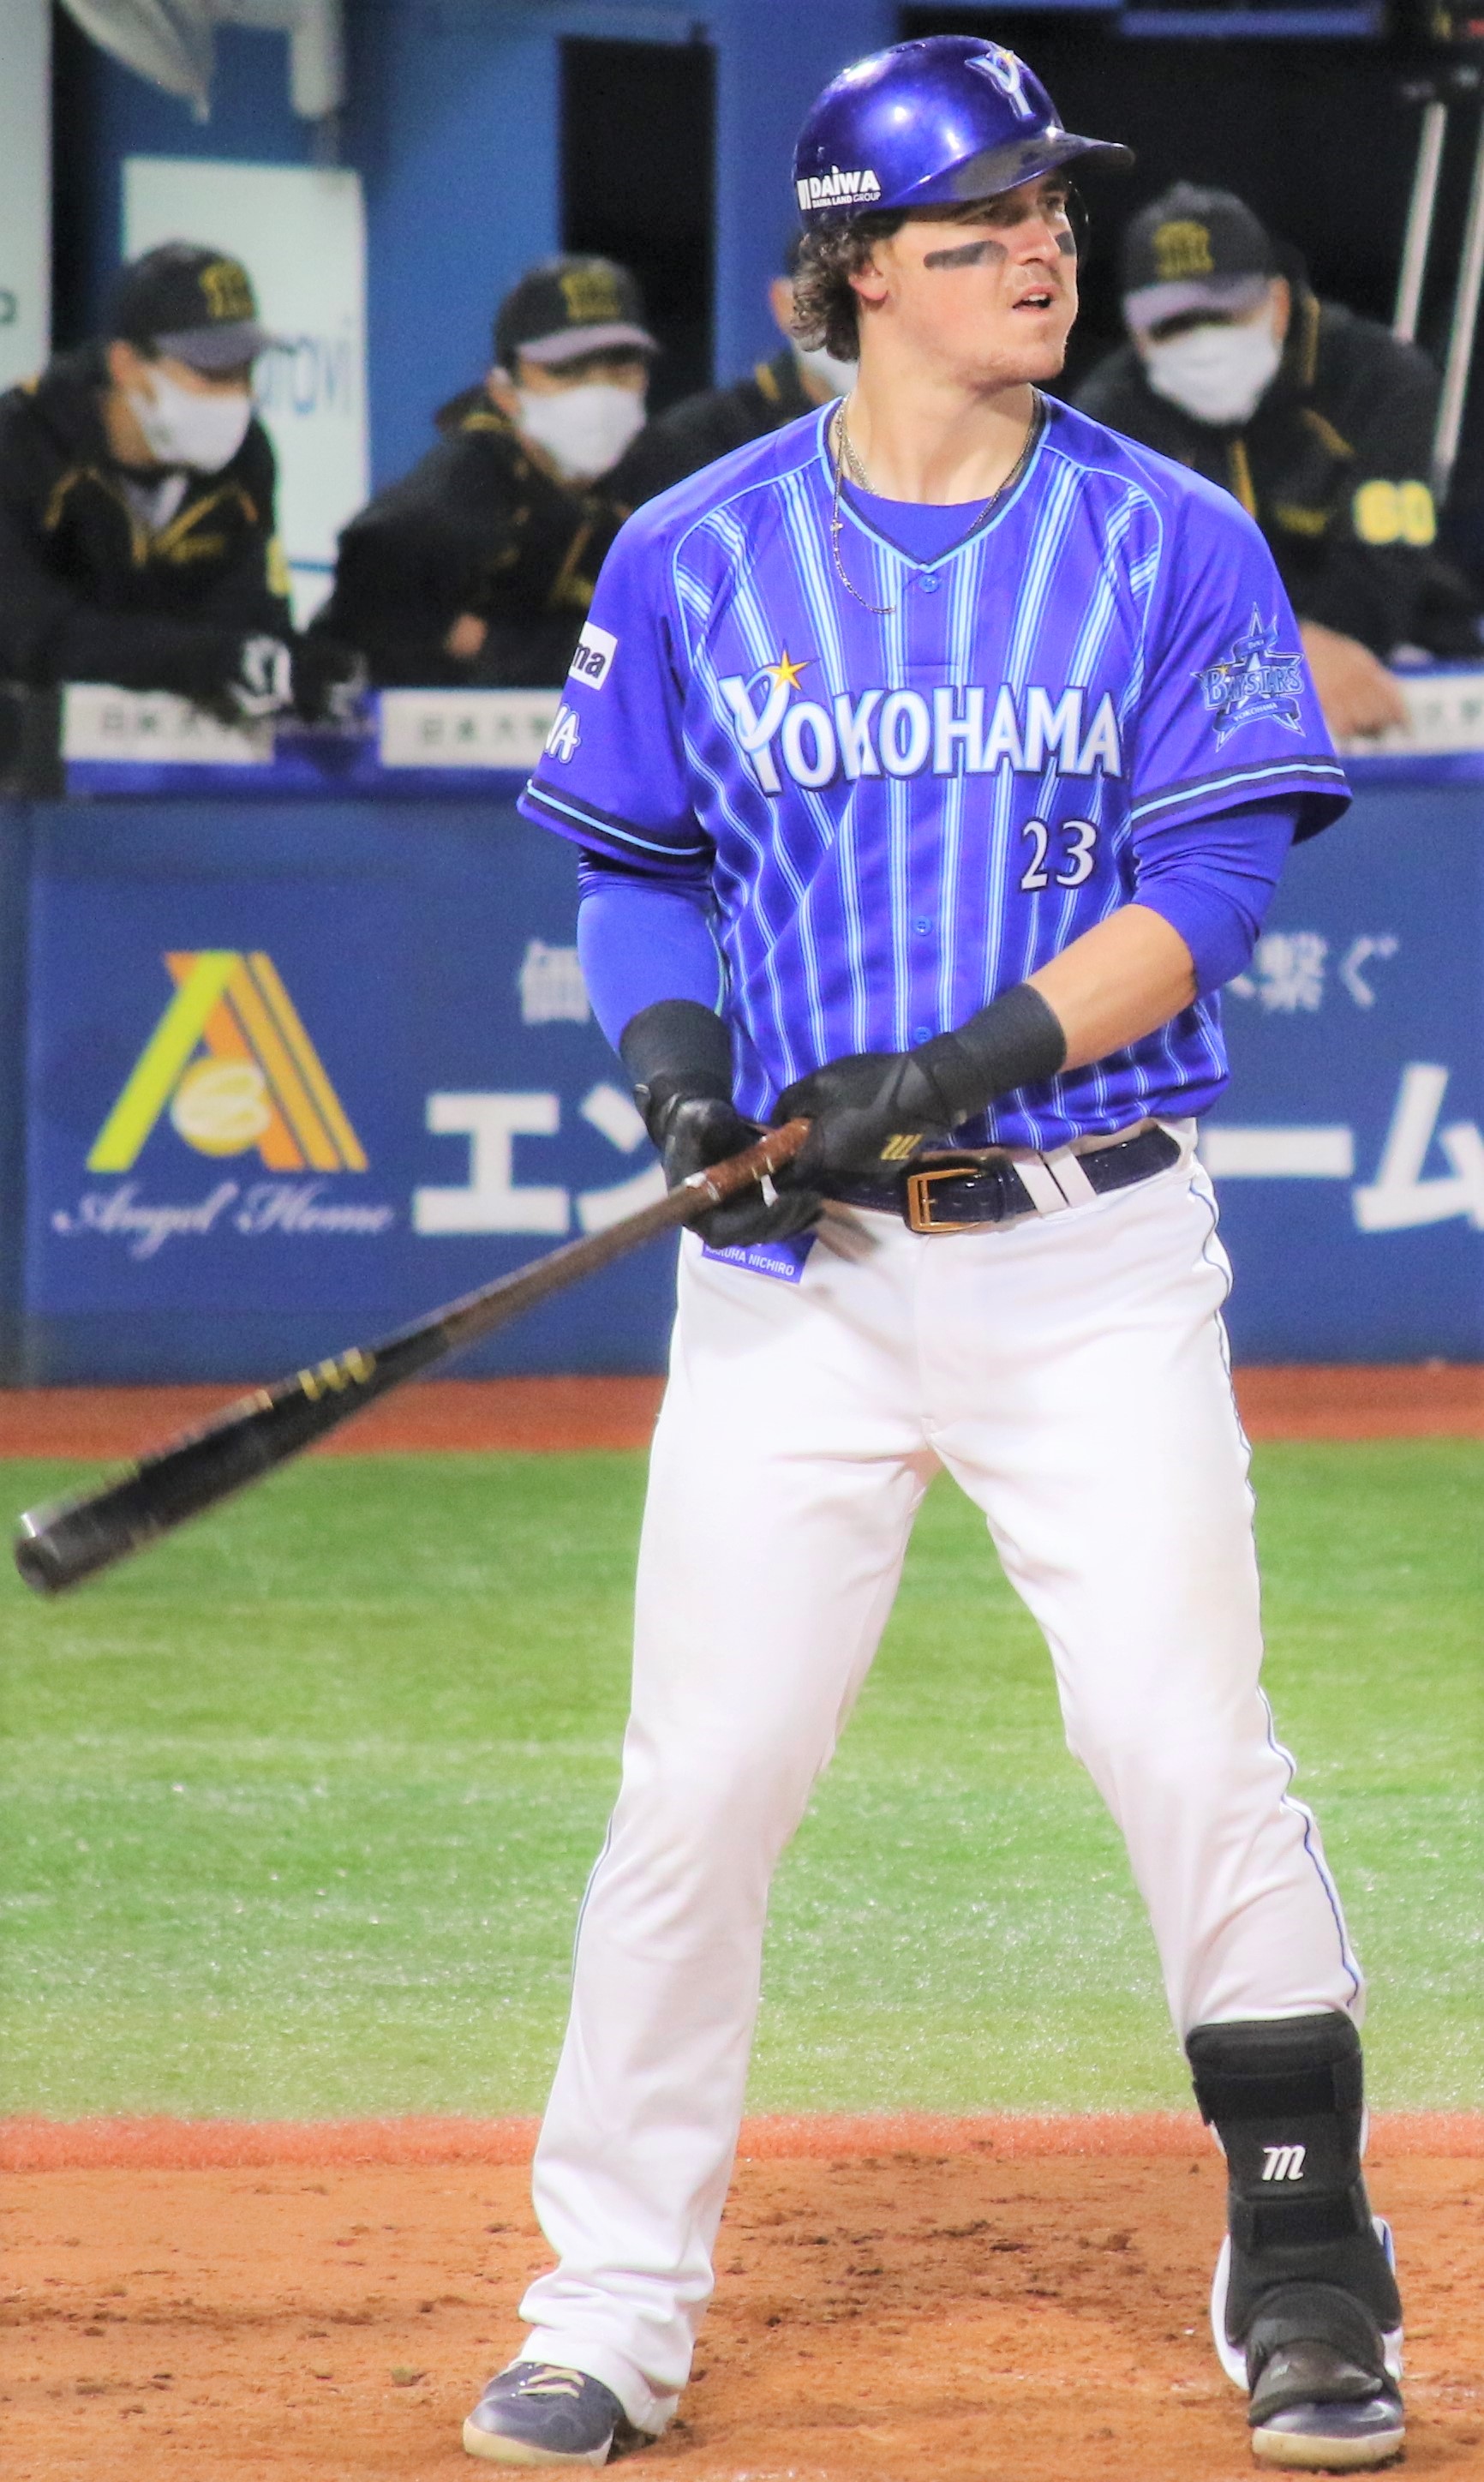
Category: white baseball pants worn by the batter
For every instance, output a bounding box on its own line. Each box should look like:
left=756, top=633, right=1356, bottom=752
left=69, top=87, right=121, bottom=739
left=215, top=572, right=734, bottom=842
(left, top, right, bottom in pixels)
left=521, top=1159, right=1362, bottom=2430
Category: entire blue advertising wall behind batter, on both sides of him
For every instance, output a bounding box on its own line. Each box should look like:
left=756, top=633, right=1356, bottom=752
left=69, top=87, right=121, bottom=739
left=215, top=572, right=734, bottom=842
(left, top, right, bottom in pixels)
left=15, top=784, right=1484, bottom=1382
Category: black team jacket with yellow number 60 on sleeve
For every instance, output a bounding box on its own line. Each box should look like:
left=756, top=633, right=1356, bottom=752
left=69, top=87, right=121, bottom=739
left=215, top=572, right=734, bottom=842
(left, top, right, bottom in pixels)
left=1074, top=285, right=1479, bottom=657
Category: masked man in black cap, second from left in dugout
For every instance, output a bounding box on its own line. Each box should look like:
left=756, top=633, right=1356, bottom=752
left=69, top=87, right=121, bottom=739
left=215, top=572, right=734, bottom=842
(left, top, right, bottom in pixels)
left=315, top=258, right=658, bottom=687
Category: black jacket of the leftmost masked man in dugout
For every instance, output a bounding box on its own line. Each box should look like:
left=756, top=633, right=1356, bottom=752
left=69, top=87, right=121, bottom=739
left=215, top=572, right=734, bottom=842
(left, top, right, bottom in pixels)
left=0, top=345, right=290, bottom=704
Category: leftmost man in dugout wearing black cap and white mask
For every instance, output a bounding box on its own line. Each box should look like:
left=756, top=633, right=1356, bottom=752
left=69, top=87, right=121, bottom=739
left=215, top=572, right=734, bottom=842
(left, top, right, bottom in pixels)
left=0, top=241, right=360, bottom=722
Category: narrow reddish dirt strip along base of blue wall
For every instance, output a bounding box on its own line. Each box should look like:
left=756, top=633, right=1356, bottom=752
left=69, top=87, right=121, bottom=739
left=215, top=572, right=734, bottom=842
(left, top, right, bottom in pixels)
left=0, top=1363, right=1484, bottom=1457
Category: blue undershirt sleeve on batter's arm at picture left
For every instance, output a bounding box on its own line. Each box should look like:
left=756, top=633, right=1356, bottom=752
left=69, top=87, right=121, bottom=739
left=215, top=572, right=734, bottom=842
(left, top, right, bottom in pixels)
left=578, top=851, right=725, bottom=1050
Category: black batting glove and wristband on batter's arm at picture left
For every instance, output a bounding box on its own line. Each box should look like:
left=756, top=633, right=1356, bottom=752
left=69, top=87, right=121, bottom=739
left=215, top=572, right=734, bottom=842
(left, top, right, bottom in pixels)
left=618, top=1000, right=824, bottom=1249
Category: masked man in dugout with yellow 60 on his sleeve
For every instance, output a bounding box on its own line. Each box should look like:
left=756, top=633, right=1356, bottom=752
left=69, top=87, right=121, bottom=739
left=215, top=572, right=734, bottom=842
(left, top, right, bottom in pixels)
left=1074, top=181, right=1479, bottom=737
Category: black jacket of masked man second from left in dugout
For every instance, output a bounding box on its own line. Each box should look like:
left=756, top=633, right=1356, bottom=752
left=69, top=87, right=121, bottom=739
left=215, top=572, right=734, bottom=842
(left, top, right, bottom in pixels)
left=315, top=387, right=633, bottom=687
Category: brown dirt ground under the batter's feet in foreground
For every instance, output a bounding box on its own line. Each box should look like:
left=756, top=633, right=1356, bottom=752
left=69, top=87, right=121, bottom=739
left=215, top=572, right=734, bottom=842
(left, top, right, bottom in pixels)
left=0, top=2114, right=1484, bottom=2482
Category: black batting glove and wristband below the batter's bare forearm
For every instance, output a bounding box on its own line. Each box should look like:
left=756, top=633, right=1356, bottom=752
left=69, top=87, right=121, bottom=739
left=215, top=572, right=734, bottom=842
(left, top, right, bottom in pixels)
left=772, top=983, right=1067, bottom=1191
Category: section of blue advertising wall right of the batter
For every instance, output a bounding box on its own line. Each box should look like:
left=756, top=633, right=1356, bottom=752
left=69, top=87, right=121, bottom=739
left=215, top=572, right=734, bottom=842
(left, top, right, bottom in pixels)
left=1201, top=784, right=1484, bottom=1363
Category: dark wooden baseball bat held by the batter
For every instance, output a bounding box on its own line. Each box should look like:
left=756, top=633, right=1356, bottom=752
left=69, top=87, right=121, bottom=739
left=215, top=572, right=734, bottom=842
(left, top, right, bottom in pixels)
left=15, top=1119, right=809, bottom=1593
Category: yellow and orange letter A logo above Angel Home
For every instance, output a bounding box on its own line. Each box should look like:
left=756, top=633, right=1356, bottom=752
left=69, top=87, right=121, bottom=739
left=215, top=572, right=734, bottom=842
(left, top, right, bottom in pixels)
left=87, top=948, right=368, bottom=1172
